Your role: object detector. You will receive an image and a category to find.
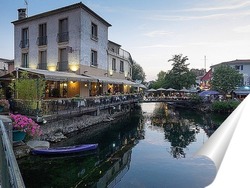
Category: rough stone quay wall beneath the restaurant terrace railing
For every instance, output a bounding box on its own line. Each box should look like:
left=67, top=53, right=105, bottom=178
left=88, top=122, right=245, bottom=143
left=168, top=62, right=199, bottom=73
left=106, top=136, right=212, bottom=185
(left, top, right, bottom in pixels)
left=39, top=103, right=137, bottom=142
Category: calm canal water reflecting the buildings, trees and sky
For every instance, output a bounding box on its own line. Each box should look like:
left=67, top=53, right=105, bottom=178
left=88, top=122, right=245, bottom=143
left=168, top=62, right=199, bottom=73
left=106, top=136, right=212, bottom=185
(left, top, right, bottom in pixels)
left=18, top=103, right=226, bottom=188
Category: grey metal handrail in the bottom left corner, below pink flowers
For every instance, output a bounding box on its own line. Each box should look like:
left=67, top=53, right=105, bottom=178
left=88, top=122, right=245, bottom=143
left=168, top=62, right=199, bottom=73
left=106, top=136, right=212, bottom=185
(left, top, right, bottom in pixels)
left=0, top=120, right=25, bottom=188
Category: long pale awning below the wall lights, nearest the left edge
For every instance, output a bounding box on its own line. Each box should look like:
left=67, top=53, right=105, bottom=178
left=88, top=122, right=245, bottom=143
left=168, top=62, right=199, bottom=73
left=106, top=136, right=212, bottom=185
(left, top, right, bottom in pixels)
left=18, top=68, right=96, bottom=81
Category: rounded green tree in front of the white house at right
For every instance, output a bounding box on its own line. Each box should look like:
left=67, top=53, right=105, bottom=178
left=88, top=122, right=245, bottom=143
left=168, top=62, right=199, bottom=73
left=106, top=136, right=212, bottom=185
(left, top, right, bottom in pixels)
left=211, top=65, right=243, bottom=95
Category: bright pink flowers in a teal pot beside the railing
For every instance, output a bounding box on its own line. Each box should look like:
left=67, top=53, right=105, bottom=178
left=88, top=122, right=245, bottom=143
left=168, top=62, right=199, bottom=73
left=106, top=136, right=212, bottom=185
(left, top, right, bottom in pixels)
left=10, top=114, right=42, bottom=141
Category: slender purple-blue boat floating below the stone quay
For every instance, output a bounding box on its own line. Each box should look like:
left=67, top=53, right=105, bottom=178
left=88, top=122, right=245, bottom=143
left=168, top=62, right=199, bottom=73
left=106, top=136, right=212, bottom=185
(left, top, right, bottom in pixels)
left=31, top=144, right=98, bottom=155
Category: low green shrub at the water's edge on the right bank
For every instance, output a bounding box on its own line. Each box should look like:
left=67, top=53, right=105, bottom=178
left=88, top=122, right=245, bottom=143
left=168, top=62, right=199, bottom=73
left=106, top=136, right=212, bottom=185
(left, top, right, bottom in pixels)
left=212, top=100, right=240, bottom=113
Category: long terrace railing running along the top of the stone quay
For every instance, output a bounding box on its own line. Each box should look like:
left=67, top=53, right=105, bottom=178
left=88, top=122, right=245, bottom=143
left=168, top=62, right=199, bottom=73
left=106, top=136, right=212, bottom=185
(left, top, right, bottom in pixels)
left=14, top=94, right=140, bottom=116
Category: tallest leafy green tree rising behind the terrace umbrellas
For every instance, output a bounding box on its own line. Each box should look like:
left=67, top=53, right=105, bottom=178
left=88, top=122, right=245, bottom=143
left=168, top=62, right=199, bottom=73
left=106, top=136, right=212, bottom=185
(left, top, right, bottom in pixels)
left=165, top=54, right=196, bottom=89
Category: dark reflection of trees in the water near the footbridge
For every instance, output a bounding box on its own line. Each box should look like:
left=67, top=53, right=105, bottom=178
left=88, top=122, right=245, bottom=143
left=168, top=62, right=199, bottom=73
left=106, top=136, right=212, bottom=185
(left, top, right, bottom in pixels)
left=150, top=103, right=226, bottom=159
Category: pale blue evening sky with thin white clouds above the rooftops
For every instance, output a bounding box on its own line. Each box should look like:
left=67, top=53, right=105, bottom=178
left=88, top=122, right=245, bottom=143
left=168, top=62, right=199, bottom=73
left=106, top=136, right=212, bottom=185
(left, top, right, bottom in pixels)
left=0, top=0, right=250, bottom=81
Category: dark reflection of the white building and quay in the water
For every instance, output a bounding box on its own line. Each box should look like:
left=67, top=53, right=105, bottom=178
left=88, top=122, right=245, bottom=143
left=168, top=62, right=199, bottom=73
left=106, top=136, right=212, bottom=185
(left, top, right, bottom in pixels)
left=18, top=110, right=144, bottom=188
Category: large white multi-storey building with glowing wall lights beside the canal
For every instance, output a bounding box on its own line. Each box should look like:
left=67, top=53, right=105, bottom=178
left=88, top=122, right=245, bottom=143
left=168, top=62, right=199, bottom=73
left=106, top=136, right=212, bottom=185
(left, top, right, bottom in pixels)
left=12, top=3, right=133, bottom=97
